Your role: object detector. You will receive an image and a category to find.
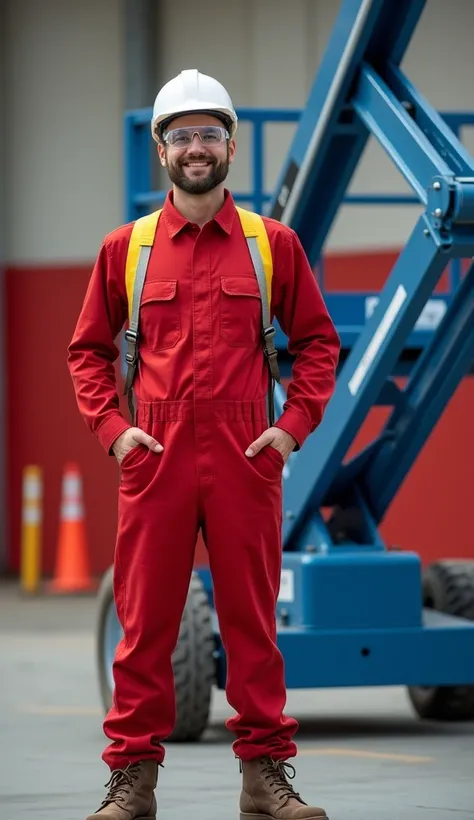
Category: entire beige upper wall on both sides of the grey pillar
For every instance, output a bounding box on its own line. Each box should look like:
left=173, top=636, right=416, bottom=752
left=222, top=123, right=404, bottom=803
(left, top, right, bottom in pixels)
left=6, top=0, right=474, bottom=262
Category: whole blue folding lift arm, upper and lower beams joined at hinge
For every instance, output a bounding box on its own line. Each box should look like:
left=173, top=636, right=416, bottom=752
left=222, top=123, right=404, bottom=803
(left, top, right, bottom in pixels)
left=270, top=0, right=474, bottom=550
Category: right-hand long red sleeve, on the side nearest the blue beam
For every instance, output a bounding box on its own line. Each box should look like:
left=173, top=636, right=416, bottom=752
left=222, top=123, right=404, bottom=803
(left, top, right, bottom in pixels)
left=274, top=229, right=340, bottom=449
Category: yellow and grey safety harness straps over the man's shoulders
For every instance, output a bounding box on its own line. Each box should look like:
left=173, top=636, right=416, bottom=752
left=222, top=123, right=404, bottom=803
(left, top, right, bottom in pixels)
left=124, top=208, right=280, bottom=426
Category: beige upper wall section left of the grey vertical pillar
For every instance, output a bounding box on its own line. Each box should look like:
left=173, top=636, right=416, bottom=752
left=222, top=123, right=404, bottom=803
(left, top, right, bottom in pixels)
left=6, top=0, right=123, bottom=262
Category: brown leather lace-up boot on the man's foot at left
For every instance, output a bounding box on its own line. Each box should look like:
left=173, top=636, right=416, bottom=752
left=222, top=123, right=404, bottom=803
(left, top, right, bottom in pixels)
left=86, top=760, right=158, bottom=820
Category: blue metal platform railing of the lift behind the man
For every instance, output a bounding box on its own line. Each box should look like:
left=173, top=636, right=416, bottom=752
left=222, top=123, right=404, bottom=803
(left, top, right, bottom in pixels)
left=125, top=108, right=474, bottom=351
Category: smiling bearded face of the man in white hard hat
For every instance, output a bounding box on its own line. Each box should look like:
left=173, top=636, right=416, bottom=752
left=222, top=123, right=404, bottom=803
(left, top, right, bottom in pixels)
left=158, top=114, right=235, bottom=194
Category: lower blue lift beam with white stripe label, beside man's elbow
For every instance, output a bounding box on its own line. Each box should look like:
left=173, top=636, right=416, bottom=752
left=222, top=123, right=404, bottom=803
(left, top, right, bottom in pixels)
left=283, top=215, right=456, bottom=548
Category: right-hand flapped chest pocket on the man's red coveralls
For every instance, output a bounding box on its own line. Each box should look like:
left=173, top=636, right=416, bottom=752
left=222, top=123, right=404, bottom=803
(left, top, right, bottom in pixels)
left=220, top=276, right=262, bottom=347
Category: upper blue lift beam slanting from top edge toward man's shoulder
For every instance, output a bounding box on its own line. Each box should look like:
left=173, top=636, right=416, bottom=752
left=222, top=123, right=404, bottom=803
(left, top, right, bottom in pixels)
left=269, top=0, right=425, bottom=264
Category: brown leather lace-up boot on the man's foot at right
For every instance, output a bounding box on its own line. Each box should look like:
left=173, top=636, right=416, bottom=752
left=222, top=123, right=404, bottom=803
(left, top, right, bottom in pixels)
left=240, top=757, right=328, bottom=820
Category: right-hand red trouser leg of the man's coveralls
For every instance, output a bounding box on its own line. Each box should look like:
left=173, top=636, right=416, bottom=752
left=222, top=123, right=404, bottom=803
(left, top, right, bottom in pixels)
left=205, top=410, right=298, bottom=760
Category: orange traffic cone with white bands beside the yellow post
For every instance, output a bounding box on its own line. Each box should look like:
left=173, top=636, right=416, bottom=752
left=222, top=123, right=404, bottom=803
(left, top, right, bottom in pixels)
left=48, top=464, right=95, bottom=592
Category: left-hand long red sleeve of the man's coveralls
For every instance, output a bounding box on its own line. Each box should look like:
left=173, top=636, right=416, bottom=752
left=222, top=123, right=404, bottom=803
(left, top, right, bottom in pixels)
left=68, top=240, right=131, bottom=453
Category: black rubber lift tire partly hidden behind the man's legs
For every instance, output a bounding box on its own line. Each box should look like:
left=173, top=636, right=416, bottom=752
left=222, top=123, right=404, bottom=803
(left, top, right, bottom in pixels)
left=96, top=567, right=216, bottom=743
